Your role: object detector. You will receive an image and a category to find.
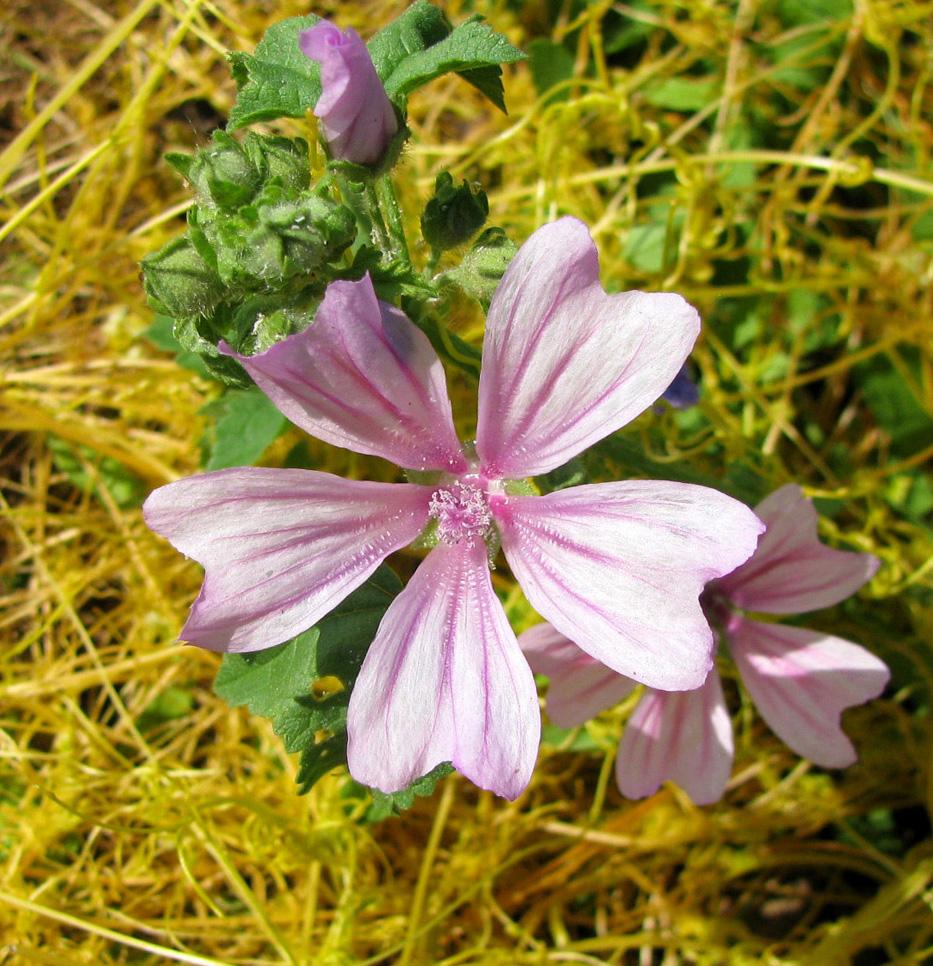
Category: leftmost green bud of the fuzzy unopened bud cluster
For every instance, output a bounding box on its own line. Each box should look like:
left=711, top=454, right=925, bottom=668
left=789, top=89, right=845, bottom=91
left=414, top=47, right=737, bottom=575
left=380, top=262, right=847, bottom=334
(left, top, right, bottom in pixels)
left=142, top=237, right=223, bottom=319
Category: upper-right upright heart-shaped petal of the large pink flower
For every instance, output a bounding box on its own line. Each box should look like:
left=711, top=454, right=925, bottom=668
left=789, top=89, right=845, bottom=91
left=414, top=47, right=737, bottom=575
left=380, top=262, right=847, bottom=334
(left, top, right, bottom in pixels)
left=476, top=218, right=700, bottom=479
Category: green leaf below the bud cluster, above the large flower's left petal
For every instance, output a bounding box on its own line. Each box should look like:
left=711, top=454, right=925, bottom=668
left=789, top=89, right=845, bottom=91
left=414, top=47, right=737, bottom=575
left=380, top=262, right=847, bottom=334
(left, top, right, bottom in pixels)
left=201, top=388, right=287, bottom=471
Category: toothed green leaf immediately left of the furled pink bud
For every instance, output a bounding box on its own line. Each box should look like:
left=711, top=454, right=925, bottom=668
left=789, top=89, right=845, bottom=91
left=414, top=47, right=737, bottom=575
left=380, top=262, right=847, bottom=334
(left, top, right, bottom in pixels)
left=227, top=14, right=321, bottom=131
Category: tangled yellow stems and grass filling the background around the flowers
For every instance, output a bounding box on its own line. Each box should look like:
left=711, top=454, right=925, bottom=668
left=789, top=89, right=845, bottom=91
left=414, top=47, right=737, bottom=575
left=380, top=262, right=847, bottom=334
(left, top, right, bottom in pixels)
left=0, top=0, right=933, bottom=966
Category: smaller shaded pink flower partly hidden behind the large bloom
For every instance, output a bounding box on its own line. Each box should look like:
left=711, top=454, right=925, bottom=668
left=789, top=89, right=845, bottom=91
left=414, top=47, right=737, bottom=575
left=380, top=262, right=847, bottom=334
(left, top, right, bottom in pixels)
left=519, top=483, right=889, bottom=805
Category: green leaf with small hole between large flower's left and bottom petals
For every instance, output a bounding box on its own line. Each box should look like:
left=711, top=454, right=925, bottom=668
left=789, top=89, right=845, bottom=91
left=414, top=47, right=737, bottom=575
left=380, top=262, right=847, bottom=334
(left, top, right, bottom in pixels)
left=214, top=564, right=402, bottom=794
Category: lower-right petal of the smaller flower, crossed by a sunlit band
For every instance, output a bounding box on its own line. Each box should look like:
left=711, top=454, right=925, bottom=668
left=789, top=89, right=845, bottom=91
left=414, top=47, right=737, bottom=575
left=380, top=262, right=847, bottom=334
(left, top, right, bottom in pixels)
left=726, top=617, right=890, bottom=768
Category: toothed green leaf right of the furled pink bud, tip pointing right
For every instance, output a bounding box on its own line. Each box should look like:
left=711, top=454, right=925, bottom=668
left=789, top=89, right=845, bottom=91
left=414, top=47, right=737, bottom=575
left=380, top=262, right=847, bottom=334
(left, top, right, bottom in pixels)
left=384, top=19, right=525, bottom=111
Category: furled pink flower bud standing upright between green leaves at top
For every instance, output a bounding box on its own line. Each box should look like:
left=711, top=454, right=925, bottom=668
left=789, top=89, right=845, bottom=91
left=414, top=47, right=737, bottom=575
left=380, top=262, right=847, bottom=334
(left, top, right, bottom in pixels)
left=298, top=20, right=398, bottom=165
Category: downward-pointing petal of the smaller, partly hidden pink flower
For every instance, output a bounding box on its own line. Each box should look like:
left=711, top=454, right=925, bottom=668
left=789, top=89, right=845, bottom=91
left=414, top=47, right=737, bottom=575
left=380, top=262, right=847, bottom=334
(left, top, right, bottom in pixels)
left=616, top=671, right=733, bottom=805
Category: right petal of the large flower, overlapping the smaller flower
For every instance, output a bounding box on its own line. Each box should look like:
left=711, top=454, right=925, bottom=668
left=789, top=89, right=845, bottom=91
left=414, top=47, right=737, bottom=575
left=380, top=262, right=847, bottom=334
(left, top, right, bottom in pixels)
left=489, top=488, right=762, bottom=691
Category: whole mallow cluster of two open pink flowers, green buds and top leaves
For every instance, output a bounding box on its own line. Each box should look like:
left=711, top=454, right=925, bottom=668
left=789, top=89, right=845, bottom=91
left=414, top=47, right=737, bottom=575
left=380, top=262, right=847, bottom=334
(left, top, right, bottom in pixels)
left=143, top=11, right=887, bottom=802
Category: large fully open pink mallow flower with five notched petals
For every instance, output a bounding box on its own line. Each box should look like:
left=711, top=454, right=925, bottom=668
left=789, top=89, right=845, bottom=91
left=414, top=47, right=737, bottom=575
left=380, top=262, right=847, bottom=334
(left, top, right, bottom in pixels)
left=144, top=218, right=763, bottom=798
